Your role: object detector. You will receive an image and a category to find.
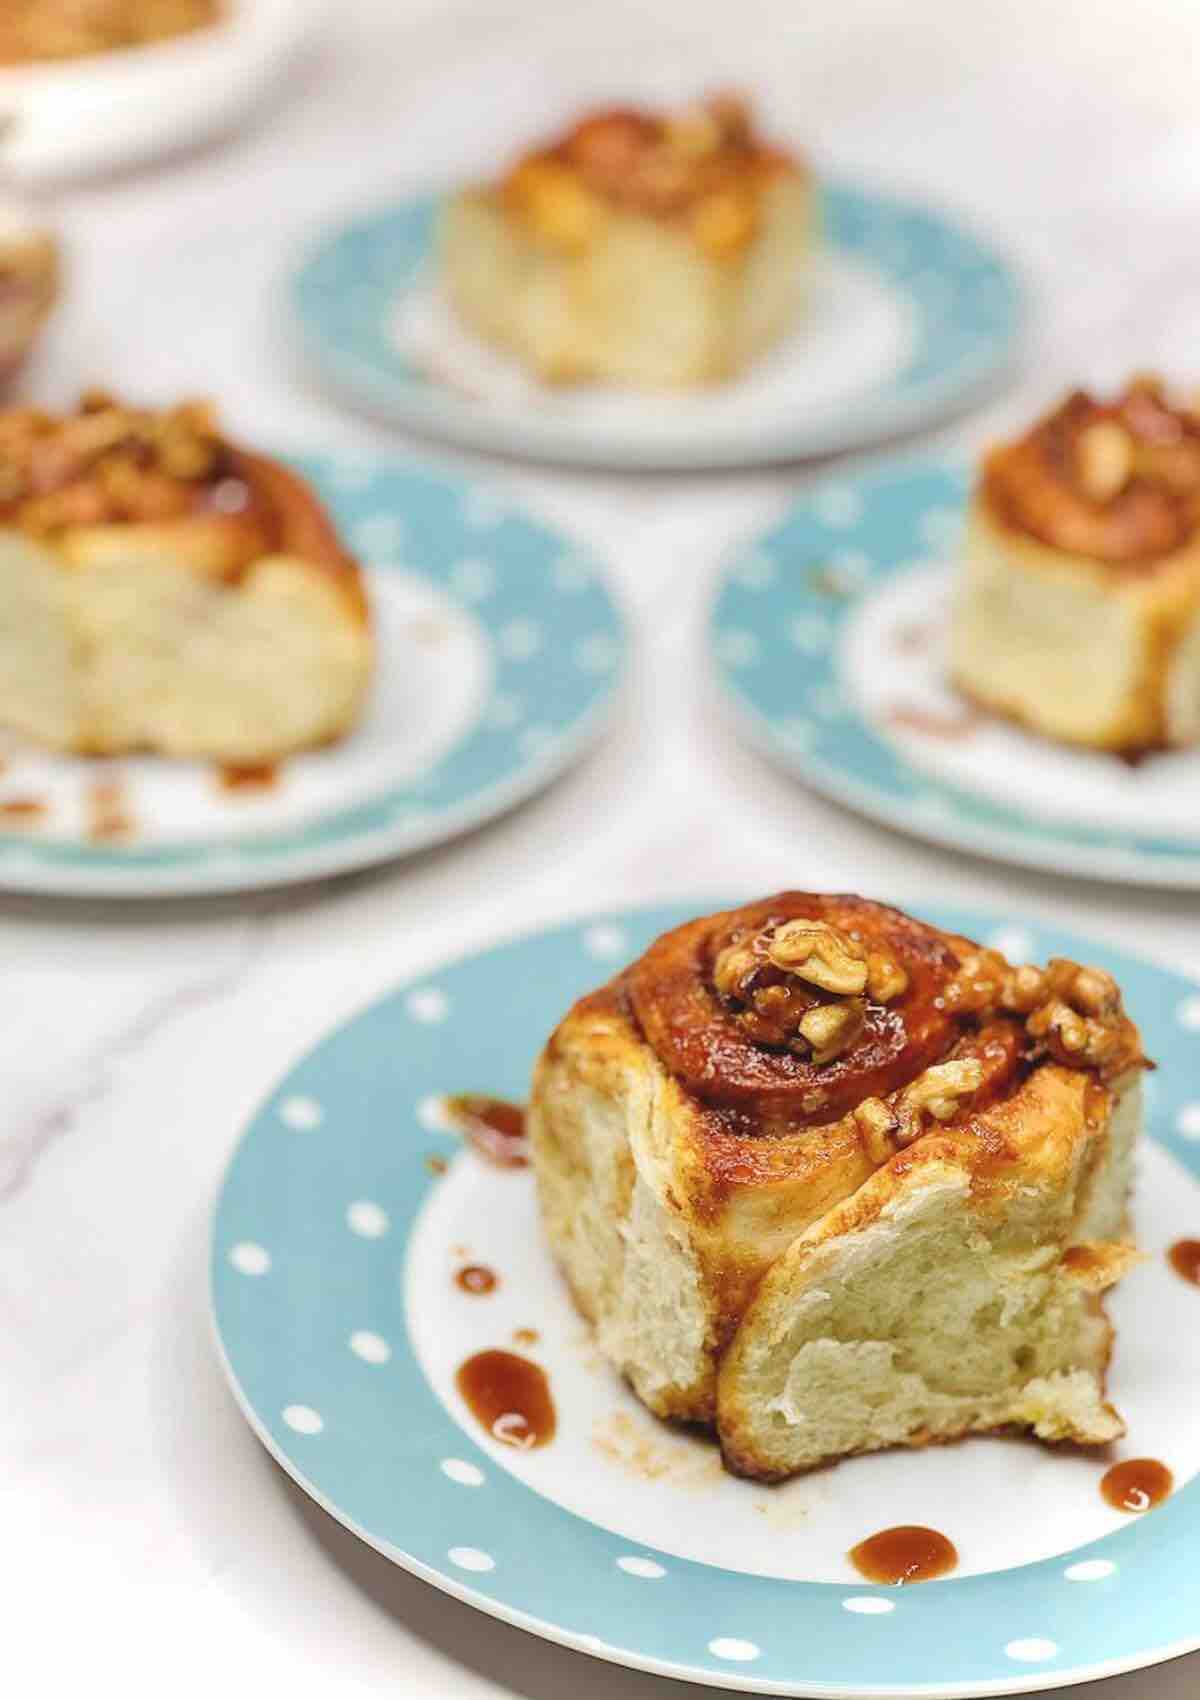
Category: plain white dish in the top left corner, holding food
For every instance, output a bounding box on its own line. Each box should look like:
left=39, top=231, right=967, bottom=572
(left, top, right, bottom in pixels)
left=0, top=0, right=328, bottom=185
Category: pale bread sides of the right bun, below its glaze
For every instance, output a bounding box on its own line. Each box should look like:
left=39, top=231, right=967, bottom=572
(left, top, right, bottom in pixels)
left=950, top=498, right=1200, bottom=750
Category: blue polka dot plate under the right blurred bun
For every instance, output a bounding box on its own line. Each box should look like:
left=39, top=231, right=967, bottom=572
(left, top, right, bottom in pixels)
left=709, top=461, right=1200, bottom=886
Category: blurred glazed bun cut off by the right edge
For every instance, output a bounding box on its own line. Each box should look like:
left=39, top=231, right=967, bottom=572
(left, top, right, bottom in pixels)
left=950, top=379, right=1200, bottom=753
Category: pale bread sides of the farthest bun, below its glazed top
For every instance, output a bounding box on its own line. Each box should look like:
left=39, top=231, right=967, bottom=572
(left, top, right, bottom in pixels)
left=442, top=172, right=812, bottom=389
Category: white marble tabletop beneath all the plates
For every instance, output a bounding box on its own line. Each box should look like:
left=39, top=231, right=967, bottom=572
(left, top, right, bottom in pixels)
left=0, top=0, right=1200, bottom=1700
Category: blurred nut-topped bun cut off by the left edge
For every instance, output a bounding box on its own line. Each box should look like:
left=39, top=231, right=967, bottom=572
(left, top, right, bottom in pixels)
left=0, top=394, right=372, bottom=763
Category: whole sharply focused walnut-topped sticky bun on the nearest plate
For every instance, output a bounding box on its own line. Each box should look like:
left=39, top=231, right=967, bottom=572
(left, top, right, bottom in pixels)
left=529, top=891, right=1146, bottom=1479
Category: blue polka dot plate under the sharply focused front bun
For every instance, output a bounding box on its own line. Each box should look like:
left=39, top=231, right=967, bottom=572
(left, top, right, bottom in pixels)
left=211, top=897, right=1200, bottom=1700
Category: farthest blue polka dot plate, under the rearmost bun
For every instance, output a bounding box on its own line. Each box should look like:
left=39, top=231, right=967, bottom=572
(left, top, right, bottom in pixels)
left=287, top=184, right=1023, bottom=468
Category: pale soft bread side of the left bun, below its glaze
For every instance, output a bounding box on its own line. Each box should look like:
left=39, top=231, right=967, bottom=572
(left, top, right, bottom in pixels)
left=0, top=530, right=371, bottom=763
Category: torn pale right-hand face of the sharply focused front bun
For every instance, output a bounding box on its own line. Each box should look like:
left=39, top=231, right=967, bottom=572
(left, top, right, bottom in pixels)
left=719, top=1071, right=1139, bottom=1477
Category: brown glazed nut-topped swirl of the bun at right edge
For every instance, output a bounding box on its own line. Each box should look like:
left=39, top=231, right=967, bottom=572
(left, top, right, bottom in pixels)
left=979, top=377, right=1200, bottom=575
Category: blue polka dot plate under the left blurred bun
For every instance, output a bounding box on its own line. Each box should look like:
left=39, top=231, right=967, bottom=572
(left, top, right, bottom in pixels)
left=0, top=457, right=625, bottom=898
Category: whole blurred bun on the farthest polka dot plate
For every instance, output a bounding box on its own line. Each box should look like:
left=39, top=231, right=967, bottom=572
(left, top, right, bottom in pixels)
left=442, top=97, right=814, bottom=389
